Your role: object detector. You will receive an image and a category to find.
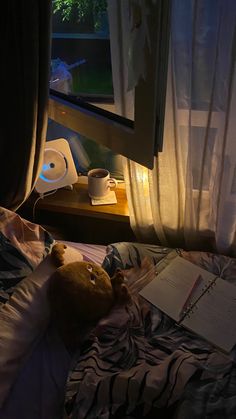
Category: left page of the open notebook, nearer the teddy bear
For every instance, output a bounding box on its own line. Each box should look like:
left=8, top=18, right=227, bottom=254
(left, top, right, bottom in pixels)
left=139, top=256, right=215, bottom=321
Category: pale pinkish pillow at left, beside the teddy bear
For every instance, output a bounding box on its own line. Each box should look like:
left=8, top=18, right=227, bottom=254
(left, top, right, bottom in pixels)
left=0, top=241, right=83, bottom=407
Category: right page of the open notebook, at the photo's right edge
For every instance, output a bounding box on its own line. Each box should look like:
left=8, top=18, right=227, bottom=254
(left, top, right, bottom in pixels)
left=182, top=278, right=236, bottom=352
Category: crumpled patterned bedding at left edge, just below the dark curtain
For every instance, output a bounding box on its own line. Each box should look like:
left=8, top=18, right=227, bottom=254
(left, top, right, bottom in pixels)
left=0, top=207, right=53, bottom=307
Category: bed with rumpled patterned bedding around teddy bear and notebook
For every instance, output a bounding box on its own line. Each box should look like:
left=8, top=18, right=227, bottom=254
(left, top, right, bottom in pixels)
left=0, top=208, right=236, bottom=419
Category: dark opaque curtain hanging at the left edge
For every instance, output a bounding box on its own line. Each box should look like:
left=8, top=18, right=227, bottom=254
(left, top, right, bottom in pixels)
left=0, top=0, right=51, bottom=210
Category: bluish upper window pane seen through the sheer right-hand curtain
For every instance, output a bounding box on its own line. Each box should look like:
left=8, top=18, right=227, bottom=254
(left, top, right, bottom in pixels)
left=172, top=0, right=228, bottom=111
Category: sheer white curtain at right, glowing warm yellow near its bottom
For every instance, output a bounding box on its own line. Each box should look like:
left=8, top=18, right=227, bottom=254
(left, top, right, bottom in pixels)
left=109, top=0, right=236, bottom=254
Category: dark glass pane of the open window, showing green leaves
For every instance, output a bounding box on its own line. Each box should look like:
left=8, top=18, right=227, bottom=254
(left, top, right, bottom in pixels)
left=50, top=0, right=114, bottom=111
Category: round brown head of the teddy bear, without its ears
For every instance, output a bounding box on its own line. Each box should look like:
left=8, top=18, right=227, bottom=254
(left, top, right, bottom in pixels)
left=49, top=261, right=114, bottom=324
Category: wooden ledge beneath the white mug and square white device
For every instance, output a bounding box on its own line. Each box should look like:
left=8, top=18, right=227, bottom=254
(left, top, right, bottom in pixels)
left=17, top=182, right=136, bottom=244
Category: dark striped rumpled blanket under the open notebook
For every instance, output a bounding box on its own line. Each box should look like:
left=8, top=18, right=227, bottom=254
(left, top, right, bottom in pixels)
left=64, top=243, right=236, bottom=419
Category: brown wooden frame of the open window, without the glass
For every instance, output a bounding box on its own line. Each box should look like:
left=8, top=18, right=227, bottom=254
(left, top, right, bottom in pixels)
left=48, top=0, right=171, bottom=169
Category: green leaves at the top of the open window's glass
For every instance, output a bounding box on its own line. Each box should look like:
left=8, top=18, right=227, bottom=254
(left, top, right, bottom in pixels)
left=53, top=0, right=107, bottom=31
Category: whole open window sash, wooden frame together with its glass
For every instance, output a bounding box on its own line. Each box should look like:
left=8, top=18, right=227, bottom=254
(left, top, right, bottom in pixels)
left=49, top=0, right=170, bottom=168
